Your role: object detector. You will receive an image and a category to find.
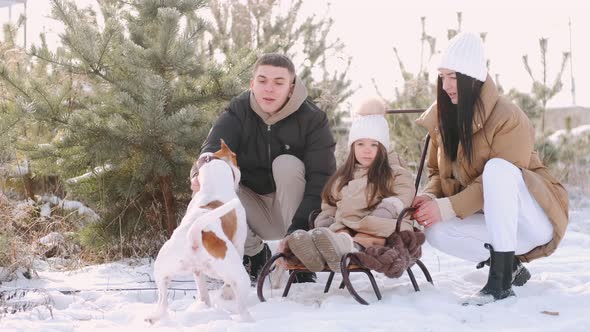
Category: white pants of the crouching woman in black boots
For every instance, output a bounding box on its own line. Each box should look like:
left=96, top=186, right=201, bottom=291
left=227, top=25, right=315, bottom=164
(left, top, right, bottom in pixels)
left=425, top=158, right=553, bottom=262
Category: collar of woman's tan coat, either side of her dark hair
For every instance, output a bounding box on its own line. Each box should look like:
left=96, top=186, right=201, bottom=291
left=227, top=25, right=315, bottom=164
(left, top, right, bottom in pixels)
left=416, top=75, right=500, bottom=134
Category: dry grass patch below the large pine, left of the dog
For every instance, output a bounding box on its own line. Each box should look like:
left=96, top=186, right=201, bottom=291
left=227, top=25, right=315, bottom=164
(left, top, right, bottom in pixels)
left=0, top=193, right=167, bottom=282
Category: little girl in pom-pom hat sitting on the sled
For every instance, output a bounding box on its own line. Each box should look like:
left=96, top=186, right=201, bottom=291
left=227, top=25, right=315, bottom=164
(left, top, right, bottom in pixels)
left=286, top=99, right=415, bottom=272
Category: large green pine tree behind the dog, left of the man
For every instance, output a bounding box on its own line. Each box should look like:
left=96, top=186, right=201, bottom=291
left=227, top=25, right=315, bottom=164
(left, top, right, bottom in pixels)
left=5, top=0, right=229, bottom=244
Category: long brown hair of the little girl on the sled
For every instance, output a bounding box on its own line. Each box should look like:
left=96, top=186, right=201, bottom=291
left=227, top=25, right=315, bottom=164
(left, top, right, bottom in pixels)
left=322, top=143, right=395, bottom=210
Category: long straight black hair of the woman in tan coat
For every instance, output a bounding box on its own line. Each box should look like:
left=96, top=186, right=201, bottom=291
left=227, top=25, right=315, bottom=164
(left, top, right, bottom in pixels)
left=436, top=72, right=483, bottom=163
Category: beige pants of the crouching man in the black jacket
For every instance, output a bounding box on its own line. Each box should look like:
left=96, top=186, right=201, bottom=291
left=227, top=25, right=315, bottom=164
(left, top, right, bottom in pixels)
left=238, top=155, right=305, bottom=256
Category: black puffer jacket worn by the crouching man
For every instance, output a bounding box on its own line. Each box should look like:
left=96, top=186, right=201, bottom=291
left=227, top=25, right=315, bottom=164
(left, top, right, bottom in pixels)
left=201, top=91, right=336, bottom=233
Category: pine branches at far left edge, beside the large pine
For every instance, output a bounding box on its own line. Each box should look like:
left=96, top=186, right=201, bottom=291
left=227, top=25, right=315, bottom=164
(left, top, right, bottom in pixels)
left=0, top=16, right=68, bottom=199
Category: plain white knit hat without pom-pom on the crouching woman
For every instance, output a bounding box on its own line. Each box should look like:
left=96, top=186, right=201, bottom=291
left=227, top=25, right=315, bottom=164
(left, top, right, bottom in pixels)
left=438, top=32, right=488, bottom=82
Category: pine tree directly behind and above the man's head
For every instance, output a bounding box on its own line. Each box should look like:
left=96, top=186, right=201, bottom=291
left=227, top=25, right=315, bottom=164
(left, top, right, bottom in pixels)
left=207, top=0, right=353, bottom=125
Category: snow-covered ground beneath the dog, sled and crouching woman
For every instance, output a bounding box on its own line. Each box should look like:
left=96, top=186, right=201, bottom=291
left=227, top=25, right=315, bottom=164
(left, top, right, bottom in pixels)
left=0, top=191, right=590, bottom=332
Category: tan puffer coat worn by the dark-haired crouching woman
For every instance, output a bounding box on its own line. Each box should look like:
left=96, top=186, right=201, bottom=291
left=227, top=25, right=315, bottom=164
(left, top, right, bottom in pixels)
left=416, top=76, right=568, bottom=261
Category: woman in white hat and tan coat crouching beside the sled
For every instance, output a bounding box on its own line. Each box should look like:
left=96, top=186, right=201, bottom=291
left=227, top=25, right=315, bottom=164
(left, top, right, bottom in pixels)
left=413, top=33, right=568, bottom=304
